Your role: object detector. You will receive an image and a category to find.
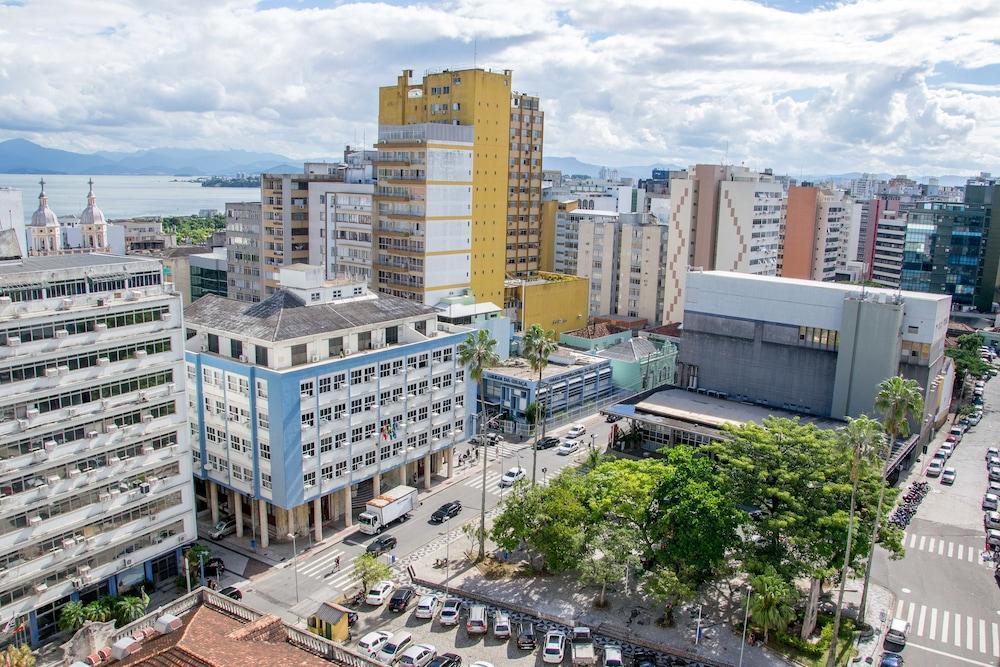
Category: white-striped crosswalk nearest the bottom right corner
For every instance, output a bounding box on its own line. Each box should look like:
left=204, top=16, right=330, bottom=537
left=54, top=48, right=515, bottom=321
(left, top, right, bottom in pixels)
left=895, top=599, right=1000, bottom=658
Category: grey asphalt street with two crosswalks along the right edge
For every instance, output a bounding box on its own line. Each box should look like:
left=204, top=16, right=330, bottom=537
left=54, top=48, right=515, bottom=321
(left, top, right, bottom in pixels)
left=872, top=379, right=1000, bottom=667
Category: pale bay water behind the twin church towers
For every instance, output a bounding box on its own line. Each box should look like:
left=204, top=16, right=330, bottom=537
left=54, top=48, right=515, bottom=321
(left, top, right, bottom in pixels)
left=0, top=174, right=260, bottom=222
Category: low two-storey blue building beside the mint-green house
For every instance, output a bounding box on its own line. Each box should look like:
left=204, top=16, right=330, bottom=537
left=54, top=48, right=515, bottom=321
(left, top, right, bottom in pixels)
left=483, top=347, right=615, bottom=426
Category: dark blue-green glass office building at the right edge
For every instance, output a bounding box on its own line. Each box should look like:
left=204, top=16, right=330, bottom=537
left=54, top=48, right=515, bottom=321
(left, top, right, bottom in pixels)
left=900, top=183, right=1000, bottom=312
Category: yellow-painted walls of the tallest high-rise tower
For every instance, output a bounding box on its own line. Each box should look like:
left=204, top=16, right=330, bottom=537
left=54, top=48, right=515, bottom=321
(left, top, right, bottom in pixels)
left=373, top=69, right=512, bottom=305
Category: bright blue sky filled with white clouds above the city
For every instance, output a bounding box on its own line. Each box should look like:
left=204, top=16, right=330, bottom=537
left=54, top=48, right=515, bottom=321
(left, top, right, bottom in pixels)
left=0, top=0, right=1000, bottom=176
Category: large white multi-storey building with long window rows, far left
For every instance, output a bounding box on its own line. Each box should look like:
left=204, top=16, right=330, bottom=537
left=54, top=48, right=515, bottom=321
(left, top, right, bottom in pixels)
left=0, top=254, right=196, bottom=644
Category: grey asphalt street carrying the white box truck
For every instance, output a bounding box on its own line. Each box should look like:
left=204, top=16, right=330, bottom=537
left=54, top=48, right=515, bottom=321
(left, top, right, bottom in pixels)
left=240, top=415, right=611, bottom=622
